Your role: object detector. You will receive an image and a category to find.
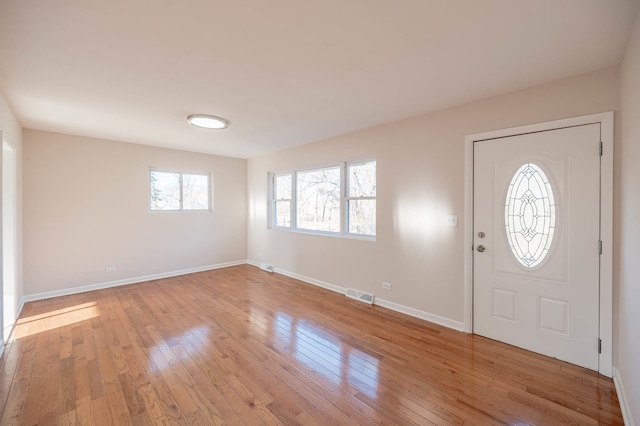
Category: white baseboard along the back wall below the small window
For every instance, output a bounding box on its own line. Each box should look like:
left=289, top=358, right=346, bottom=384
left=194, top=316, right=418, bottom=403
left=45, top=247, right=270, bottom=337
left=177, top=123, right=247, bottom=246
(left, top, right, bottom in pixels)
left=18, top=260, right=247, bottom=306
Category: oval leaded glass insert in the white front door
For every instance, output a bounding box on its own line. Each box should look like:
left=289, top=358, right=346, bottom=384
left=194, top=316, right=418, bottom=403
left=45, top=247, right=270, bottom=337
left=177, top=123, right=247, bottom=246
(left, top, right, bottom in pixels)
left=504, top=163, right=556, bottom=268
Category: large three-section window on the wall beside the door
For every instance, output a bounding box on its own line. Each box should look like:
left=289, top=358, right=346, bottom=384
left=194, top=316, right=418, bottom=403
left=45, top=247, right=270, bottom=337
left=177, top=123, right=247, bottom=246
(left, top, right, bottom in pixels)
left=270, top=160, right=376, bottom=237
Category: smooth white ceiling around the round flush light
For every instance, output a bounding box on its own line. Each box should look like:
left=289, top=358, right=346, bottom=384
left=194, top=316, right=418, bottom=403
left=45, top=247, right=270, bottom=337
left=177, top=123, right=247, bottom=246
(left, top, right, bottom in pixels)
left=0, top=0, right=638, bottom=158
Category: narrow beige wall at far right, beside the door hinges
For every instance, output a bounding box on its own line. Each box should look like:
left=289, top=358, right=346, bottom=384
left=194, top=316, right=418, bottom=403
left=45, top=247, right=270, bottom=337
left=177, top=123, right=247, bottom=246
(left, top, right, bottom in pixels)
left=616, top=8, right=640, bottom=424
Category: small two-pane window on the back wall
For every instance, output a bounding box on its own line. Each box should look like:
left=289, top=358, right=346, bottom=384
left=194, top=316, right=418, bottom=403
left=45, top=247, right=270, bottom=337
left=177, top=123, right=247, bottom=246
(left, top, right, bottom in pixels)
left=149, top=170, right=211, bottom=211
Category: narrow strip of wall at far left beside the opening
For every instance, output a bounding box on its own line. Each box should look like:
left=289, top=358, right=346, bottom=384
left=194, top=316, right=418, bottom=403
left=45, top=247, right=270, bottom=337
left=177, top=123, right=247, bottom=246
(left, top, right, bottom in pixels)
left=0, top=89, right=23, bottom=340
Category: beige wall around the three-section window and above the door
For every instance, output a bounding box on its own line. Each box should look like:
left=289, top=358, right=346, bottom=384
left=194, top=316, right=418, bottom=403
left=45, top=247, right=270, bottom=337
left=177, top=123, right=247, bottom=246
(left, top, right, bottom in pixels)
left=248, top=68, right=619, bottom=323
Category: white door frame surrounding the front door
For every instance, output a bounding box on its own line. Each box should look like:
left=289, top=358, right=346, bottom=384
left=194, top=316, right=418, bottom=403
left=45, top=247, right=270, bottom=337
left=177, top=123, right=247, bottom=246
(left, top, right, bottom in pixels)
left=464, top=111, right=614, bottom=377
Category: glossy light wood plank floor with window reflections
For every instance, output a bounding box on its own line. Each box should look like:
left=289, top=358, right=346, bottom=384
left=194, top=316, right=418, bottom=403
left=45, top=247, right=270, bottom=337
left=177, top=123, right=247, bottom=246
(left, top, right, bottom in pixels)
left=0, top=265, right=622, bottom=425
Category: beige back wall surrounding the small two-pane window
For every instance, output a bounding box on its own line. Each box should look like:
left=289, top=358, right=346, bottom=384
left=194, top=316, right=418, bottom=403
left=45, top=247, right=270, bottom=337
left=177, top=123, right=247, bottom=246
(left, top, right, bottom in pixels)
left=24, top=130, right=247, bottom=296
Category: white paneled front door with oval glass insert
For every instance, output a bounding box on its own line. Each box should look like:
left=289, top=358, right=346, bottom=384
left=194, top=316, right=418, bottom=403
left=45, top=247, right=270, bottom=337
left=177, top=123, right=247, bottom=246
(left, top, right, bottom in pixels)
left=473, top=123, right=601, bottom=371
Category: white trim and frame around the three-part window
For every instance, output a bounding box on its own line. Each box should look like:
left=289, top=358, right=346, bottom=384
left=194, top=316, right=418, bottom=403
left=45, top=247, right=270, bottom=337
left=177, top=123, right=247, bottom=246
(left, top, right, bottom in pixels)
left=267, top=157, right=377, bottom=241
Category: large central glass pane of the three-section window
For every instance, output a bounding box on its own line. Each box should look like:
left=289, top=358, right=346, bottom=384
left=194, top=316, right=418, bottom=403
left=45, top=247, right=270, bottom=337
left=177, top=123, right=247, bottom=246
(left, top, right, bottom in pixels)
left=296, top=166, right=340, bottom=232
